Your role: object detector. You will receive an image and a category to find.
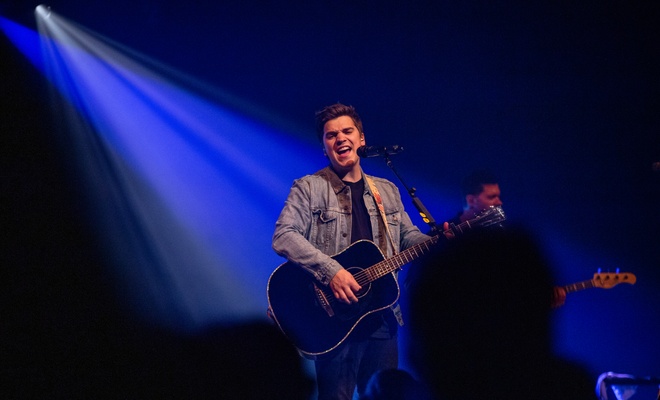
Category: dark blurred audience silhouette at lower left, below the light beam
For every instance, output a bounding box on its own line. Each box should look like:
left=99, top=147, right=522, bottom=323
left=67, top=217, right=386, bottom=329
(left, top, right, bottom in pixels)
left=120, top=321, right=314, bottom=400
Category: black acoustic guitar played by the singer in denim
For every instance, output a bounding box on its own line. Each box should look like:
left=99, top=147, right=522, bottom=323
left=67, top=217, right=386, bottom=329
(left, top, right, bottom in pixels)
left=267, top=207, right=506, bottom=358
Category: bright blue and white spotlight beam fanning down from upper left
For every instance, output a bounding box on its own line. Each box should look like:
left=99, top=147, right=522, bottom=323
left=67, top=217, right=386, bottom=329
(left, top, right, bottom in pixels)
left=2, top=6, right=325, bottom=331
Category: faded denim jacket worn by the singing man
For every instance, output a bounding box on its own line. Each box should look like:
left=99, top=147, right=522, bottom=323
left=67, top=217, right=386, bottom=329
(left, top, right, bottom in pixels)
left=273, top=166, right=429, bottom=298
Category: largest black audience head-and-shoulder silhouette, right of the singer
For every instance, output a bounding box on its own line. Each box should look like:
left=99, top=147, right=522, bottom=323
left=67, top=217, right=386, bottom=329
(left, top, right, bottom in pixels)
left=408, top=227, right=595, bottom=400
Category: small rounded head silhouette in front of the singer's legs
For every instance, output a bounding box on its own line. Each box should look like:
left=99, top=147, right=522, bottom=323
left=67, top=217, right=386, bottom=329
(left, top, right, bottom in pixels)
left=360, top=369, right=431, bottom=400
